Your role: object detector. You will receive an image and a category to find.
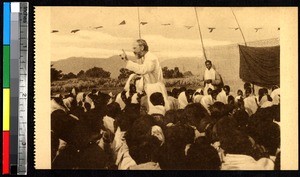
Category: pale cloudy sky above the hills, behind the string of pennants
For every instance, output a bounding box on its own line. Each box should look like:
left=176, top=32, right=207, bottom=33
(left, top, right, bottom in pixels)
left=49, top=7, right=280, bottom=61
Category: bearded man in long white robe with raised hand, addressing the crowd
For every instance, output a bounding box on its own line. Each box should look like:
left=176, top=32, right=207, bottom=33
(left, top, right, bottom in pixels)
left=120, top=39, right=169, bottom=110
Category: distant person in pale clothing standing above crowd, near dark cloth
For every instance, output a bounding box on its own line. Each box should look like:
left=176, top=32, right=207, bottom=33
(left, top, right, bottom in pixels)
left=203, top=60, right=222, bottom=95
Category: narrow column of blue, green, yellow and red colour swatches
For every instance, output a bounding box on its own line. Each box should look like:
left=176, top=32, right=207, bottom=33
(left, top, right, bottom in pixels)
left=2, top=2, right=10, bottom=174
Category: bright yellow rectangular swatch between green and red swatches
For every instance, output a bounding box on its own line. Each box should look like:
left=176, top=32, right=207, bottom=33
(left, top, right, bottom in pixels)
left=3, top=88, right=10, bottom=131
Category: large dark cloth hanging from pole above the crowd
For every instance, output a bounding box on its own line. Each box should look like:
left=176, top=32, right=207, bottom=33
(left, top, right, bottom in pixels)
left=239, top=45, right=280, bottom=88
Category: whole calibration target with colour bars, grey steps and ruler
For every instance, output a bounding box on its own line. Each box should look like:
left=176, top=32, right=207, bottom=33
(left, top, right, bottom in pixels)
left=2, top=2, right=29, bottom=175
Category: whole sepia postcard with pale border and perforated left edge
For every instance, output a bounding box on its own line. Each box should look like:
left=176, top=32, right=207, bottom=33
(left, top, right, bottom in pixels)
left=35, top=6, right=298, bottom=170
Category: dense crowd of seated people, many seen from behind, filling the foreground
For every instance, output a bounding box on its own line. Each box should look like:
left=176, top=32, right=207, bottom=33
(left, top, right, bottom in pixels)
left=51, top=79, right=280, bottom=170
